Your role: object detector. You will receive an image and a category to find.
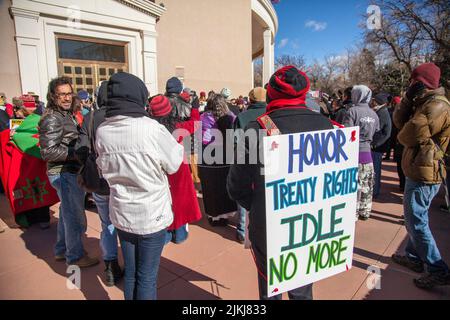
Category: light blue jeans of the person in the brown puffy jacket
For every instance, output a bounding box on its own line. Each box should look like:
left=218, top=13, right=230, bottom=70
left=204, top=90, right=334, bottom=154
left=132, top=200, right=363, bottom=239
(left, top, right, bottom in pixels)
left=403, top=177, right=448, bottom=273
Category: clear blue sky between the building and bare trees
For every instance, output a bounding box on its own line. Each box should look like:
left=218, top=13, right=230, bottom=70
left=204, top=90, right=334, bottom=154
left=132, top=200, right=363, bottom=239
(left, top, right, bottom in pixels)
left=274, top=0, right=368, bottom=64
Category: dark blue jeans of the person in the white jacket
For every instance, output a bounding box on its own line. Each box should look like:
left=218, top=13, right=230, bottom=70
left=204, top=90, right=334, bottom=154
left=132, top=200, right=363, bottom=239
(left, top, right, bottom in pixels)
left=117, top=229, right=166, bottom=300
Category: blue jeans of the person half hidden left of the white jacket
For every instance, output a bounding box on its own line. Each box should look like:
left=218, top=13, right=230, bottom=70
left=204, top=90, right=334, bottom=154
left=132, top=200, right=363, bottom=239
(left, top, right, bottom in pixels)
left=92, top=193, right=118, bottom=261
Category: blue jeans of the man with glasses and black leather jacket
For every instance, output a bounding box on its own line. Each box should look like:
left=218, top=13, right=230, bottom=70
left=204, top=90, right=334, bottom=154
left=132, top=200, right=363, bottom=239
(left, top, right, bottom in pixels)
left=48, top=172, right=87, bottom=264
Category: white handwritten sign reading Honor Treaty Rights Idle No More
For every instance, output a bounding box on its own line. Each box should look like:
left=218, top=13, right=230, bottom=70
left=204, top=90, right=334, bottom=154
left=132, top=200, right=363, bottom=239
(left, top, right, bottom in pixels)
left=264, top=127, right=359, bottom=296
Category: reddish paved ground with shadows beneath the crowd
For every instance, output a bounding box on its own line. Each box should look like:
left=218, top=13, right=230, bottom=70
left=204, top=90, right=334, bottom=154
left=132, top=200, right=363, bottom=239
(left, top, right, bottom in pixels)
left=0, top=162, right=450, bottom=300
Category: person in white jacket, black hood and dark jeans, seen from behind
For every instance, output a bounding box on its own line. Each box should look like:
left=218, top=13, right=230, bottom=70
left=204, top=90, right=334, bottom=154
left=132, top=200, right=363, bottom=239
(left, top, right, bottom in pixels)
left=95, top=72, right=183, bottom=300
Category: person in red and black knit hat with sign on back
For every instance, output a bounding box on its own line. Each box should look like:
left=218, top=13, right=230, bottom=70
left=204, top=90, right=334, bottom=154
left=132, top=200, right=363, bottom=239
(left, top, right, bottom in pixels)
left=227, top=66, right=333, bottom=300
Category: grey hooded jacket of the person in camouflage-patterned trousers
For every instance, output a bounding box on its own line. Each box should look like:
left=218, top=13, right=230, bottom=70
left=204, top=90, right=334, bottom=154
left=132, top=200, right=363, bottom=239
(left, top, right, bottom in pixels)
left=342, top=86, right=380, bottom=152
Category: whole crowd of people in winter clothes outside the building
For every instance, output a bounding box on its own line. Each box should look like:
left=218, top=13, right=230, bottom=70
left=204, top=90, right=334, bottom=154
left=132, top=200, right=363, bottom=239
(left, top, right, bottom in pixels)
left=0, top=63, right=450, bottom=299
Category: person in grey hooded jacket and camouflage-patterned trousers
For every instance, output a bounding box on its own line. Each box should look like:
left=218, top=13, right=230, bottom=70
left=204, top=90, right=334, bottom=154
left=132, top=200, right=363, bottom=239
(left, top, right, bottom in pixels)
left=342, top=85, right=380, bottom=220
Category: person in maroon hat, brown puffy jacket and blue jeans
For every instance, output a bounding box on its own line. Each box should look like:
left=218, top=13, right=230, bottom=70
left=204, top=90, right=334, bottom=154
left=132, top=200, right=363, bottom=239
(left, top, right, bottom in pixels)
left=392, top=63, right=450, bottom=289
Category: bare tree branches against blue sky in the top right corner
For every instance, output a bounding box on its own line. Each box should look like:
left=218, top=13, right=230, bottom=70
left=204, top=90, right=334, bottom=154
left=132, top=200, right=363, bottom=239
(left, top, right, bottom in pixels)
left=364, top=0, right=450, bottom=88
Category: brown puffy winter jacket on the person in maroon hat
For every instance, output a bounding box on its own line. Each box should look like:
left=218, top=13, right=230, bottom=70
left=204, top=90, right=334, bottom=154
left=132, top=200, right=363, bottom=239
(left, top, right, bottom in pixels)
left=394, top=88, right=450, bottom=184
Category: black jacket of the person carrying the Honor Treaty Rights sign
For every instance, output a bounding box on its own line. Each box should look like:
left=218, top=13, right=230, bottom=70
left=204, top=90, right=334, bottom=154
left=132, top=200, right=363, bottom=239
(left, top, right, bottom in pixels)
left=227, top=108, right=333, bottom=252
